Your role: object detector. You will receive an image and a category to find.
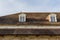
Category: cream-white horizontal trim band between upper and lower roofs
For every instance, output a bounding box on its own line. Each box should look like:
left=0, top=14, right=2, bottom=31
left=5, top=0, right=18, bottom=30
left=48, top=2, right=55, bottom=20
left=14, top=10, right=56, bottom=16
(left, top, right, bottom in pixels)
left=0, top=26, right=60, bottom=29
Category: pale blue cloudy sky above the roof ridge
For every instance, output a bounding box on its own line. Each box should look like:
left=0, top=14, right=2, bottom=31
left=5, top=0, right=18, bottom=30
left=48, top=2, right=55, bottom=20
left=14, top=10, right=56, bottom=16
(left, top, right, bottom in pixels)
left=0, top=0, right=60, bottom=16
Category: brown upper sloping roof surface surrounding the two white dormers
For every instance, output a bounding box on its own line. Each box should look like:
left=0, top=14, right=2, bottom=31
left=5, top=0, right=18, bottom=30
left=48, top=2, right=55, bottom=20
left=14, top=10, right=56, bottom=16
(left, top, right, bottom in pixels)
left=0, top=12, right=60, bottom=26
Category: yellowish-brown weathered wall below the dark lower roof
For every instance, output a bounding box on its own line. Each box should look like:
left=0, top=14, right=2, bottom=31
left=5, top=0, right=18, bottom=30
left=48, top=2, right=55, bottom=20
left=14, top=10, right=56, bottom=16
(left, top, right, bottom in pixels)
left=0, top=35, right=60, bottom=40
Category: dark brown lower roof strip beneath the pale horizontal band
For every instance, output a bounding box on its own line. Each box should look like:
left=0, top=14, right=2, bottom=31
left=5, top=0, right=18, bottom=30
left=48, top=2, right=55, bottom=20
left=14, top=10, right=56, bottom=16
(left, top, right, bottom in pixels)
left=0, top=29, right=60, bottom=35
